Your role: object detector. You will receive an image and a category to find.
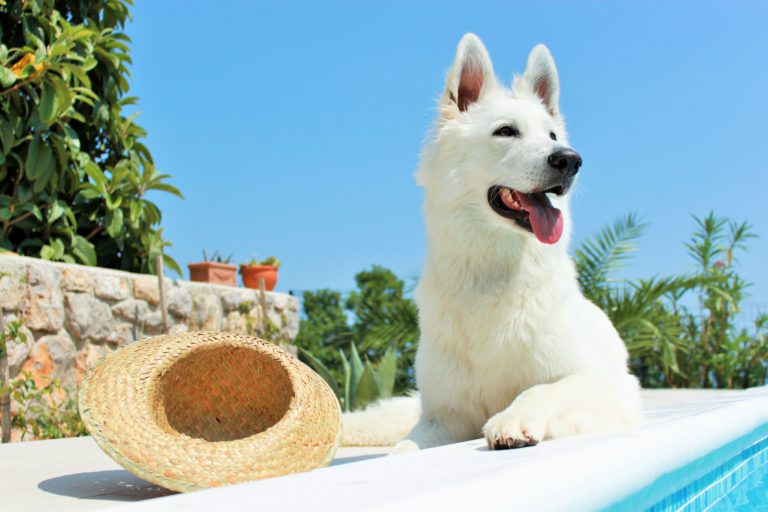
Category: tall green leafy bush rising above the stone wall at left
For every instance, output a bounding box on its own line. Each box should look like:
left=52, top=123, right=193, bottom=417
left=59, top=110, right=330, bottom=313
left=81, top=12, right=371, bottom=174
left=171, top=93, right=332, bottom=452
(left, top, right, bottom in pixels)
left=0, top=0, right=181, bottom=274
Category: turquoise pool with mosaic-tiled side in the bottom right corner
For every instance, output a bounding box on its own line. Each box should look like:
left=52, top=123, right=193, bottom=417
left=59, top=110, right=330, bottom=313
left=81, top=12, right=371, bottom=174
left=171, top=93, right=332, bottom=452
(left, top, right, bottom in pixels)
left=606, top=424, right=768, bottom=512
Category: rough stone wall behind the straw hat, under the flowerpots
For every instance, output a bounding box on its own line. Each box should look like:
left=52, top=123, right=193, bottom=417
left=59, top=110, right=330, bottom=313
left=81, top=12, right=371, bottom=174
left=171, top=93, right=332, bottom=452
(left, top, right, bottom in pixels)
left=0, top=254, right=299, bottom=386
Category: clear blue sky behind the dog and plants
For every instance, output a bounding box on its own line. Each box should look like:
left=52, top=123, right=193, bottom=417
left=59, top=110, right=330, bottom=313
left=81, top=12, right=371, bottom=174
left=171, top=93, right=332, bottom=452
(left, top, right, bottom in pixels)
left=127, top=0, right=768, bottom=309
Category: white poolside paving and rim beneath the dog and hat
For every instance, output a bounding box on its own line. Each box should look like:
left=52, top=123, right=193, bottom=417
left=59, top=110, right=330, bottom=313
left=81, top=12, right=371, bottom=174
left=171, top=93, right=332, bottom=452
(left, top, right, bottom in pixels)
left=0, top=387, right=768, bottom=512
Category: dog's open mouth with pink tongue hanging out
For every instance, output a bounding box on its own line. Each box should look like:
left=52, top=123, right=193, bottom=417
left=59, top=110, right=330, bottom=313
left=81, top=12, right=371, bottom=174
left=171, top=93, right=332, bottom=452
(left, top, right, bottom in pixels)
left=488, top=185, right=565, bottom=244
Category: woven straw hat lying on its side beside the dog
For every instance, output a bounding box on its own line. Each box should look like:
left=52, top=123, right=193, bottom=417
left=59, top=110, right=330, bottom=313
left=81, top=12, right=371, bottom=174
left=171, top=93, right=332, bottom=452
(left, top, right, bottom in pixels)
left=79, top=332, right=341, bottom=492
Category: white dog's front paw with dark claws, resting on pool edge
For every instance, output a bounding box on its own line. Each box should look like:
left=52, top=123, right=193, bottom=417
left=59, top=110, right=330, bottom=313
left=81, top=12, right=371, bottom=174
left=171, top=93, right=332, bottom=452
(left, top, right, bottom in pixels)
left=483, top=407, right=547, bottom=450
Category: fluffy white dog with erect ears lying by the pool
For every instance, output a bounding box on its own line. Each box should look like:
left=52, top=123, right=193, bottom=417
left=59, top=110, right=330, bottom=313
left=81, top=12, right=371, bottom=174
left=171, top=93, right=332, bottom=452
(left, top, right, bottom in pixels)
left=343, top=34, right=640, bottom=451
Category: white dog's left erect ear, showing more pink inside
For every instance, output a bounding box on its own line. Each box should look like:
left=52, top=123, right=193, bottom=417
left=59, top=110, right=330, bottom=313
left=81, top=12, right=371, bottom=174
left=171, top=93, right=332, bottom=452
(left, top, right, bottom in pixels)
left=443, top=34, right=496, bottom=112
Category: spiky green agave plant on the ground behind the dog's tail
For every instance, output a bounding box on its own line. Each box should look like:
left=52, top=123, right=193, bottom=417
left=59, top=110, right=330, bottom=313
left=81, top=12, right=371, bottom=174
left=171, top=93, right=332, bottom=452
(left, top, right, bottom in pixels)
left=299, top=343, right=397, bottom=412
